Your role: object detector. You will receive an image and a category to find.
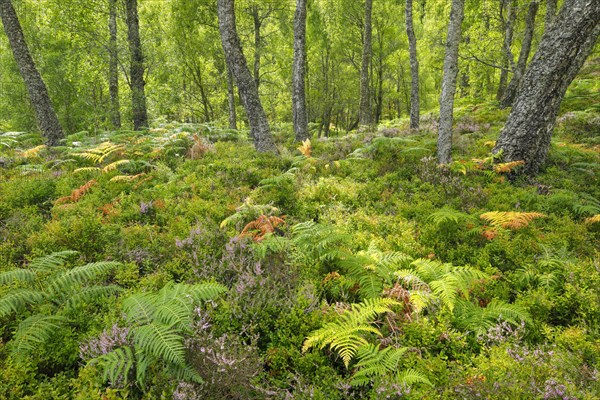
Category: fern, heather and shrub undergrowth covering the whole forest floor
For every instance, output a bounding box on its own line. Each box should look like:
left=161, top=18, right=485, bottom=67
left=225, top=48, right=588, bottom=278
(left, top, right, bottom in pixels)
left=0, top=68, right=600, bottom=399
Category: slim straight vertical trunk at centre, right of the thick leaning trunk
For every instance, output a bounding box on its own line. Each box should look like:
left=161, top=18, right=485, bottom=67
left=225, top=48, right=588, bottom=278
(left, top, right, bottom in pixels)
left=292, top=0, right=309, bottom=141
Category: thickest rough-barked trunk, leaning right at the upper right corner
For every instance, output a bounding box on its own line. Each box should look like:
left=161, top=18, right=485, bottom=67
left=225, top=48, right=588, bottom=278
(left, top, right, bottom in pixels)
left=494, top=0, right=600, bottom=174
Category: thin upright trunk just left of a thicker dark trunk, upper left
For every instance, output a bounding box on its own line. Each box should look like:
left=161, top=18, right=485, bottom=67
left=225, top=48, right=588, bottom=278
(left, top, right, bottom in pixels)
left=108, top=0, right=121, bottom=129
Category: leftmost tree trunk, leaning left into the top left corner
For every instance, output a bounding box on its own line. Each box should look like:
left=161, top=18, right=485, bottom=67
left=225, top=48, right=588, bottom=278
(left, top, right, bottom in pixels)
left=0, top=0, right=64, bottom=146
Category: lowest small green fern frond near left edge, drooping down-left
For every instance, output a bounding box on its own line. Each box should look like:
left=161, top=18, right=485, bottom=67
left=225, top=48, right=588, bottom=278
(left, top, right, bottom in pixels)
left=10, top=314, right=66, bottom=358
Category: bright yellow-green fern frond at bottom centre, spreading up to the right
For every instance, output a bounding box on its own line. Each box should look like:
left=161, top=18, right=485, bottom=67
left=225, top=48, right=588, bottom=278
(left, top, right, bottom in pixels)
left=302, top=298, right=400, bottom=367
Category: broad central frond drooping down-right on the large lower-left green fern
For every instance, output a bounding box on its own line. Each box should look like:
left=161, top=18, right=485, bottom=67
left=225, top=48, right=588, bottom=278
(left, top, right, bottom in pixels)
left=133, top=323, right=186, bottom=365
